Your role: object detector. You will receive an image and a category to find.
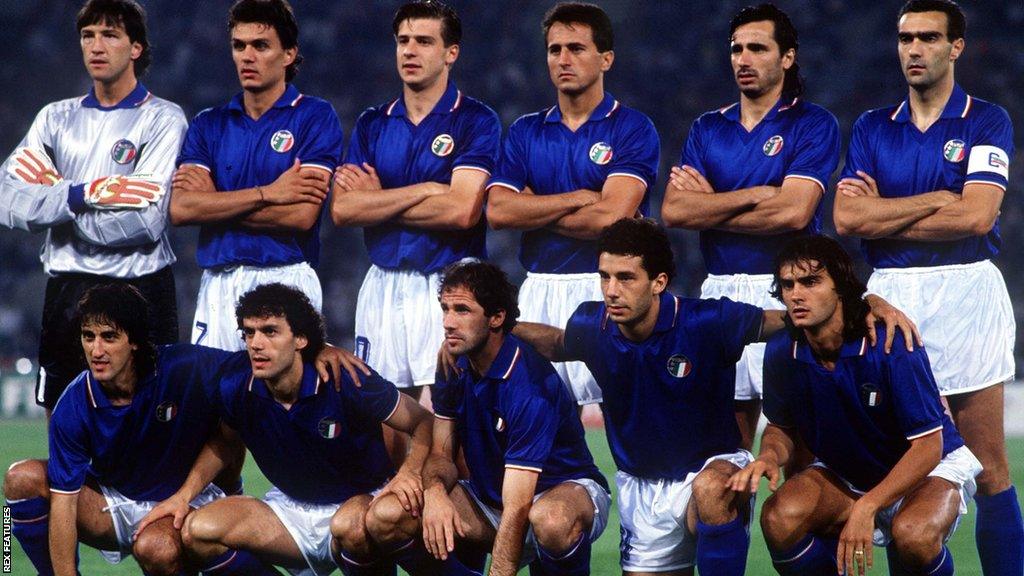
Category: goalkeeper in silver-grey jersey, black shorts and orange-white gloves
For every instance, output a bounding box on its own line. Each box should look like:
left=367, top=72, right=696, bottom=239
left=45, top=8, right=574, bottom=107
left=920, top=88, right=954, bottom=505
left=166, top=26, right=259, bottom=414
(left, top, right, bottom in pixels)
left=0, top=0, right=186, bottom=413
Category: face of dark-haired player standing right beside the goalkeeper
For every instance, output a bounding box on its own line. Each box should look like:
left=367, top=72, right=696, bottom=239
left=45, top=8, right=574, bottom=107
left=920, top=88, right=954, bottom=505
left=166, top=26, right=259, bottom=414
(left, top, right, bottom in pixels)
left=231, top=23, right=298, bottom=92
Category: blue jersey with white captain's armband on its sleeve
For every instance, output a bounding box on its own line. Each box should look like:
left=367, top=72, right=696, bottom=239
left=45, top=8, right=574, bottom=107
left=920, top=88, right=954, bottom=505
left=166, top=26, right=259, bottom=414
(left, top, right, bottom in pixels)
left=843, top=85, right=1014, bottom=268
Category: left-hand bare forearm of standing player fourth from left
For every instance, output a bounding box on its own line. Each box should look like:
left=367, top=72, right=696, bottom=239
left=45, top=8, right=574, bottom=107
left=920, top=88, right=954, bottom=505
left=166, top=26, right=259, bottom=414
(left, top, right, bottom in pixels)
left=487, top=186, right=600, bottom=230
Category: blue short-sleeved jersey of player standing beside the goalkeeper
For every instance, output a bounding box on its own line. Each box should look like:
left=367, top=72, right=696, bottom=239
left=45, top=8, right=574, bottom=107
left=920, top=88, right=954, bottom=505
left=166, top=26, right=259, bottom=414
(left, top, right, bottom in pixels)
left=178, top=84, right=344, bottom=269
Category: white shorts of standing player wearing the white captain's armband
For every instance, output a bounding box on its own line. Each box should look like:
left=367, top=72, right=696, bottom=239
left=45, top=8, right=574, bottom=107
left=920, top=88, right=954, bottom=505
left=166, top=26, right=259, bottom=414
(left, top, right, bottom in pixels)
left=867, top=260, right=1017, bottom=396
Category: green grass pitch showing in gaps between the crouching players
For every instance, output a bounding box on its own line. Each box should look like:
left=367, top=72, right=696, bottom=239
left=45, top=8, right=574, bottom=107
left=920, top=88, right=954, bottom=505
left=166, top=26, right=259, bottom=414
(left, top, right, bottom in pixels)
left=0, top=420, right=1024, bottom=576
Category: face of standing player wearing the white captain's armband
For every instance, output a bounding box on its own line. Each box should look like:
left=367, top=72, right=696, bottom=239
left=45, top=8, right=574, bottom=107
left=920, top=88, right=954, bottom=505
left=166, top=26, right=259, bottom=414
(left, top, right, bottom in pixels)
left=897, top=12, right=964, bottom=89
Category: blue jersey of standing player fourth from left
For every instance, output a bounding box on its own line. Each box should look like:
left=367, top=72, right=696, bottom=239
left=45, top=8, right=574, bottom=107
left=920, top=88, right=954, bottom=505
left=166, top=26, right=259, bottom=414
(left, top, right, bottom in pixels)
left=488, top=93, right=660, bottom=274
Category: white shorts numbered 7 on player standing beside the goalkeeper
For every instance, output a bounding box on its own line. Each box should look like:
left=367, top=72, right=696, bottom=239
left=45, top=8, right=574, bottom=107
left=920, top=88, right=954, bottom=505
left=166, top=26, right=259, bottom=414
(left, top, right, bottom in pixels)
left=191, top=262, right=324, bottom=352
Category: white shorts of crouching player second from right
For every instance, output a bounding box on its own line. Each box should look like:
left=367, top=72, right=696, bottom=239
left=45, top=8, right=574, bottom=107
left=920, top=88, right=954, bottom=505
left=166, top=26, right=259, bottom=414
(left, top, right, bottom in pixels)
left=615, top=450, right=755, bottom=572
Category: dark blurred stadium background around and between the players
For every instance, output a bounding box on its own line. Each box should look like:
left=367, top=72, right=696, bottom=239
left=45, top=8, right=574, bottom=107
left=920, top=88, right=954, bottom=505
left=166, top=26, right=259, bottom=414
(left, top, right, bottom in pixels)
left=0, top=0, right=1024, bottom=574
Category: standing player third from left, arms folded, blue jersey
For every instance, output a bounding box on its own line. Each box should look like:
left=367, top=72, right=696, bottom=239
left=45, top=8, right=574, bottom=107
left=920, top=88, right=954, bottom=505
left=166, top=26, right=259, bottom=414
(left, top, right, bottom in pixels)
left=331, top=1, right=501, bottom=420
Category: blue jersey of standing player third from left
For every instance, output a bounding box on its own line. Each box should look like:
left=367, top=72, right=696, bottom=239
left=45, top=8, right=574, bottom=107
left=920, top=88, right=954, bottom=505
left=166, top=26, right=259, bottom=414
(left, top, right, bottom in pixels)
left=345, top=82, right=502, bottom=274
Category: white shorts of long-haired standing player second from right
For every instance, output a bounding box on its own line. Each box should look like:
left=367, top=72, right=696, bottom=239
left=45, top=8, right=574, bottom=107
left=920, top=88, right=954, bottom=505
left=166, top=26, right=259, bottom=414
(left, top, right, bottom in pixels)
left=700, top=274, right=785, bottom=400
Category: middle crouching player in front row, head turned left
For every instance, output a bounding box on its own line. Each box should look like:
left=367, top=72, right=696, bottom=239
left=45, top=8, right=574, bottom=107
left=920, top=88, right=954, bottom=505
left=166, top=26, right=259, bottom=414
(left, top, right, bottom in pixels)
left=367, top=262, right=610, bottom=575
